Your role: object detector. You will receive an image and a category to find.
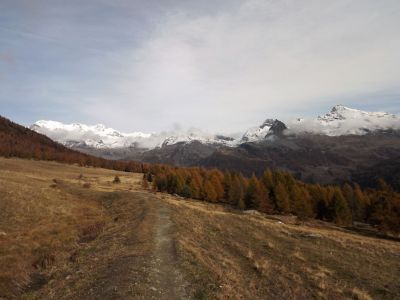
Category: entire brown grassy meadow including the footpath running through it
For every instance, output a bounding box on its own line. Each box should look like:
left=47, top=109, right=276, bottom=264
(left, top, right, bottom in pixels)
left=0, top=158, right=400, bottom=299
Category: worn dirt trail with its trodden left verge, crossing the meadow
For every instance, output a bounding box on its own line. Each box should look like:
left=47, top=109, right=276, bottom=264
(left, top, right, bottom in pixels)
left=90, top=192, right=191, bottom=299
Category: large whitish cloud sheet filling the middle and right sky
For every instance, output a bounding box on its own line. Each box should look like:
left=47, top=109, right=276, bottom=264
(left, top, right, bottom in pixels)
left=76, top=0, right=400, bottom=130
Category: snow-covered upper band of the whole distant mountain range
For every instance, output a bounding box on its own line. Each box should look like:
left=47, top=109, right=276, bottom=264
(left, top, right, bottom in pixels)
left=30, top=105, right=400, bottom=149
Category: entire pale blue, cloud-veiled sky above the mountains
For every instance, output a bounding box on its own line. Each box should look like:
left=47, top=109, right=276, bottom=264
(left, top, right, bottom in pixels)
left=0, top=0, right=400, bottom=132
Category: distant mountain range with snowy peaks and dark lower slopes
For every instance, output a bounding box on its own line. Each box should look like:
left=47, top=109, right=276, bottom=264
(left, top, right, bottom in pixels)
left=30, top=105, right=400, bottom=186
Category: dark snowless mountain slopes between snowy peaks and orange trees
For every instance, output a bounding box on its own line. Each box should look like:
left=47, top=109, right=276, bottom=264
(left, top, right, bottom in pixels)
left=141, top=133, right=400, bottom=186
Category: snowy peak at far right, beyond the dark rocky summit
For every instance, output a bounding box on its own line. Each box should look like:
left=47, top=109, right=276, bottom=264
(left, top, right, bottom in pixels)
left=288, top=105, right=400, bottom=136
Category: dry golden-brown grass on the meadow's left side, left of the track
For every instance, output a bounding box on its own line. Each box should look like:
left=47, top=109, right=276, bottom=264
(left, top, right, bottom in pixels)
left=0, top=158, right=141, bottom=298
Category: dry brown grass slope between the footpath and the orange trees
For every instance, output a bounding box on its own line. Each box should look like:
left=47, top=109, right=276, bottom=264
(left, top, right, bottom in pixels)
left=160, top=195, right=400, bottom=299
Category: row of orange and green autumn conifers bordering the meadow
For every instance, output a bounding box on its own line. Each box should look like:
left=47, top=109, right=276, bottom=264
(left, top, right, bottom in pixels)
left=144, top=165, right=400, bottom=233
